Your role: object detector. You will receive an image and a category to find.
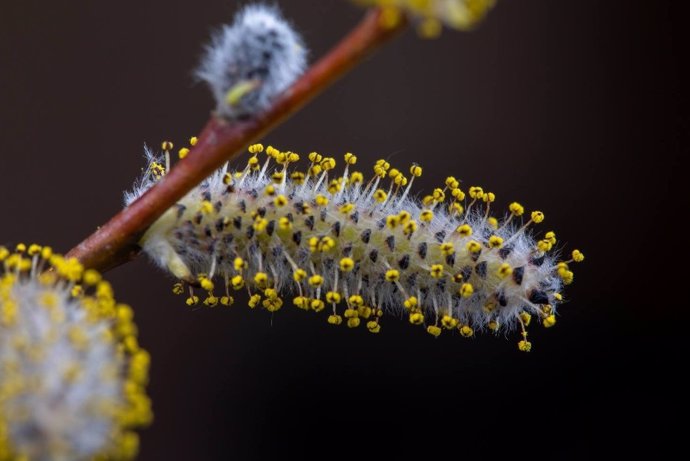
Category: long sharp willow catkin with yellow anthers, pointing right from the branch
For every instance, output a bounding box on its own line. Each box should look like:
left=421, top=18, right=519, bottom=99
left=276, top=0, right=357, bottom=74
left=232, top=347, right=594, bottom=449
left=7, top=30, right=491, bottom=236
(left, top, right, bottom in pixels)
left=125, top=138, right=584, bottom=351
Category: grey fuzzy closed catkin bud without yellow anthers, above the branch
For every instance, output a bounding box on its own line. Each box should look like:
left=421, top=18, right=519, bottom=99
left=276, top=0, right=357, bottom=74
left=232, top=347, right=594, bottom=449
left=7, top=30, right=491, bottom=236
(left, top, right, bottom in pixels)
left=196, top=4, right=307, bottom=119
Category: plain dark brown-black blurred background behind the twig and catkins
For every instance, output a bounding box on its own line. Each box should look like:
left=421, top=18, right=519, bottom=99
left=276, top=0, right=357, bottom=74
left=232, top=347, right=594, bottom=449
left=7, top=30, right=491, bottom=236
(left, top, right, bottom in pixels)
left=0, top=0, right=688, bottom=460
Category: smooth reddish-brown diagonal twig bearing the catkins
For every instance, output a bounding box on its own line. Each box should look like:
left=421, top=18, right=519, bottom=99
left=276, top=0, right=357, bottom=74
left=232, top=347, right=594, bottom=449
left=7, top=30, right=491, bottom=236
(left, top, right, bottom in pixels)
left=67, top=9, right=405, bottom=270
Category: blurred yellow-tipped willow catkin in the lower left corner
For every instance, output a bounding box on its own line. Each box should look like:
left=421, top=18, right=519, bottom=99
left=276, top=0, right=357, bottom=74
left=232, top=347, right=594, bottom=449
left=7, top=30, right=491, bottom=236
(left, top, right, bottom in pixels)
left=0, top=244, right=151, bottom=460
